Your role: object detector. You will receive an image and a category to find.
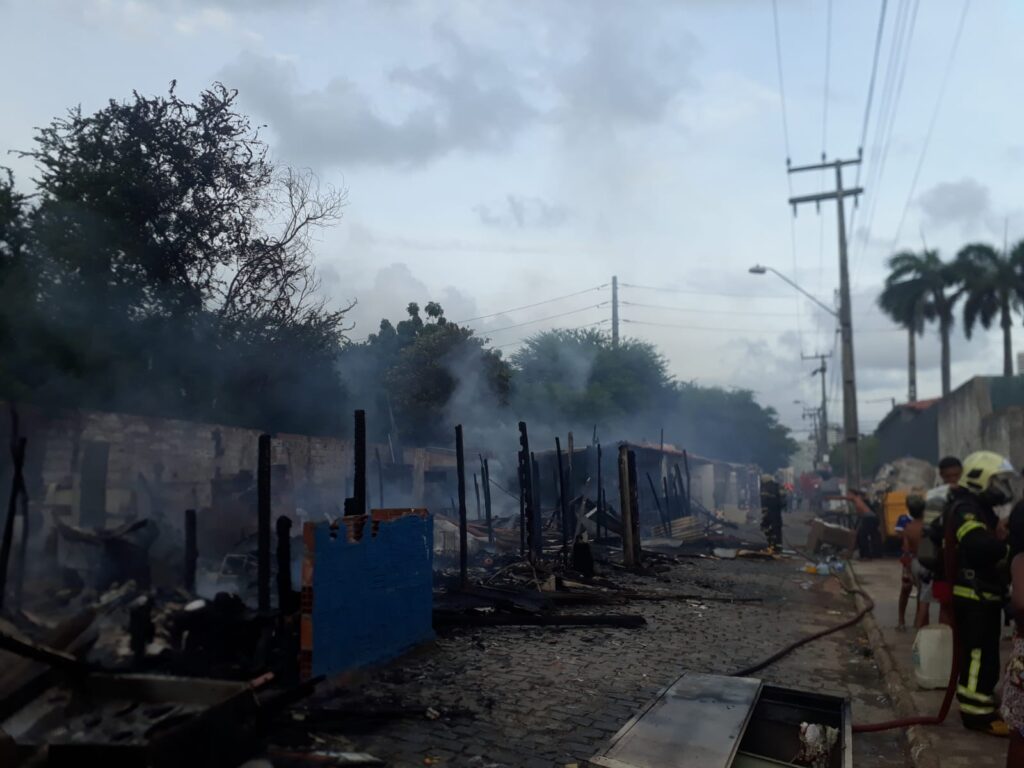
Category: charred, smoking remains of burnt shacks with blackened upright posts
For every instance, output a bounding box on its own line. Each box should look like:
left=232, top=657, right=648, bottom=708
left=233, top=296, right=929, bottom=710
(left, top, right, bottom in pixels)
left=0, top=411, right=761, bottom=768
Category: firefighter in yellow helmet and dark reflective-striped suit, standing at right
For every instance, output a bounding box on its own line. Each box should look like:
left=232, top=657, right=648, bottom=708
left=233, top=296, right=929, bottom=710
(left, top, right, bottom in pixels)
left=943, top=451, right=1014, bottom=736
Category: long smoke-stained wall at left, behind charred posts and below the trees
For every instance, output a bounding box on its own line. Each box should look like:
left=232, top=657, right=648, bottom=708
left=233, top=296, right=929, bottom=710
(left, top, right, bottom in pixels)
left=0, top=403, right=455, bottom=553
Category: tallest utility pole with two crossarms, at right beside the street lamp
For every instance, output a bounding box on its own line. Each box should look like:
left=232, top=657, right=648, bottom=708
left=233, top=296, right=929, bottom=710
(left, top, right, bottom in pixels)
left=788, top=153, right=864, bottom=488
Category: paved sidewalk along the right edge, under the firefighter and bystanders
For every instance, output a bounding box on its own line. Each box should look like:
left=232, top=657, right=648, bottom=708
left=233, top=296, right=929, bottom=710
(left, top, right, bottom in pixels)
left=851, top=559, right=1010, bottom=768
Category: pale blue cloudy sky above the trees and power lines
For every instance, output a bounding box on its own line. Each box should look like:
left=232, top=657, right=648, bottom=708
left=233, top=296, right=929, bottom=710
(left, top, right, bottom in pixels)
left=0, top=0, right=1024, bottom=442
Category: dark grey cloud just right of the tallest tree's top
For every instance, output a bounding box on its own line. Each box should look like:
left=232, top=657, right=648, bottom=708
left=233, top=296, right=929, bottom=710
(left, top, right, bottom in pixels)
left=223, top=25, right=537, bottom=165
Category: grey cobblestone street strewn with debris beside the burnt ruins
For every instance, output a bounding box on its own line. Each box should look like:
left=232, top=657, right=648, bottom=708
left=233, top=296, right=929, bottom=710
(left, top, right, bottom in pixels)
left=307, top=557, right=907, bottom=768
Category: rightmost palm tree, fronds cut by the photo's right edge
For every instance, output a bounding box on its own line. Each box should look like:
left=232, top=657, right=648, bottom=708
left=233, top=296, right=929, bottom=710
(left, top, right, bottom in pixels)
left=956, top=241, right=1024, bottom=376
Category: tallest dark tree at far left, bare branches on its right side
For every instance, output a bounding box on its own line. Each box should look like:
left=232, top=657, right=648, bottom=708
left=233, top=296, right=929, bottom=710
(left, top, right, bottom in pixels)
left=4, top=83, right=345, bottom=432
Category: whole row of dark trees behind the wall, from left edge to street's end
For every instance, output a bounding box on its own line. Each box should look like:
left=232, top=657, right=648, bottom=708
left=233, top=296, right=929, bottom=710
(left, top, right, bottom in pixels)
left=0, top=84, right=796, bottom=469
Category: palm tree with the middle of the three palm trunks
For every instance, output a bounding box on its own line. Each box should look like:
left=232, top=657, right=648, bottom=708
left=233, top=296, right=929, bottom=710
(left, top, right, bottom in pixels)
left=880, top=249, right=964, bottom=395
